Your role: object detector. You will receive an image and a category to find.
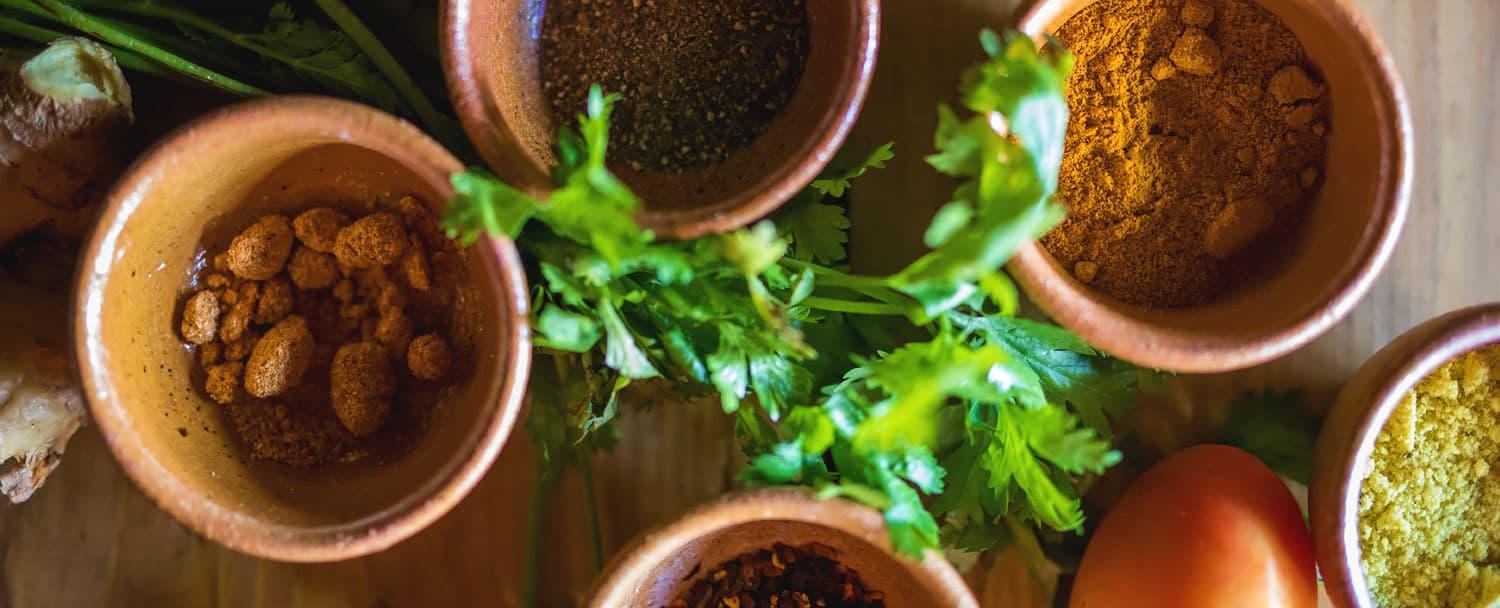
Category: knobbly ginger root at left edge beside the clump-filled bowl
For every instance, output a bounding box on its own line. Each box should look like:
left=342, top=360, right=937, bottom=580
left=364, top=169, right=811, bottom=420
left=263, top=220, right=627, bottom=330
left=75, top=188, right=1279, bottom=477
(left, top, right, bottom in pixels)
left=0, top=38, right=134, bottom=503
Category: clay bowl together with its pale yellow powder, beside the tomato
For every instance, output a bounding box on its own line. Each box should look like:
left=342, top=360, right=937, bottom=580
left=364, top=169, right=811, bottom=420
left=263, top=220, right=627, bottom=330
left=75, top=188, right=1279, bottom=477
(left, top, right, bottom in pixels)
left=1310, top=303, right=1500, bottom=608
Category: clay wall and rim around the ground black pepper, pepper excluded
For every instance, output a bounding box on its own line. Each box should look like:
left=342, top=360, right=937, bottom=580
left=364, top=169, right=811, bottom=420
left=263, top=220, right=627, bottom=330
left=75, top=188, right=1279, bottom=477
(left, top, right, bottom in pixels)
left=443, top=0, right=881, bottom=239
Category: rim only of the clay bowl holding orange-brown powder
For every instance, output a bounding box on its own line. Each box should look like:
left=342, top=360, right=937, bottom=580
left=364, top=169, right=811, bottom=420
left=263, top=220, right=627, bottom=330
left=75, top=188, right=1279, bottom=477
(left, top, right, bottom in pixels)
left=1008, top=0, right=1415, bottom=374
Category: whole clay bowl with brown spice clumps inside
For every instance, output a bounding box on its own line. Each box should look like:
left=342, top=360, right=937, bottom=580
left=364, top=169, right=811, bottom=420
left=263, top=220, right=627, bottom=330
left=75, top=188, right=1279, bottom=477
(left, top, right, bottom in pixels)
left=74, top=98, right=530, bottom=561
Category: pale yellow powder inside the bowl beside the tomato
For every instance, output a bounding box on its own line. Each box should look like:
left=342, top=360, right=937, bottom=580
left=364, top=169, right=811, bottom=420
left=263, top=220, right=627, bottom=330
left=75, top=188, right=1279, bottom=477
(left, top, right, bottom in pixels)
left=1359, top=347, right=1500, bottom=608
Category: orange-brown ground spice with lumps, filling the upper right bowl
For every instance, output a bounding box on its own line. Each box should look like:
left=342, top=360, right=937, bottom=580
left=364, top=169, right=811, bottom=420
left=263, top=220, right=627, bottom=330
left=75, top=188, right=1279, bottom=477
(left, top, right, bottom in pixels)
left=1043, top=0, right=1329, bottom=308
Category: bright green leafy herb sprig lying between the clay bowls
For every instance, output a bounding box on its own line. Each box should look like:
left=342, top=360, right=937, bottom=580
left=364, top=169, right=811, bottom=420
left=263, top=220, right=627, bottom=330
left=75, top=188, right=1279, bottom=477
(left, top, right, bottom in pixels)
left=447, top=33, right=1140, bottom=555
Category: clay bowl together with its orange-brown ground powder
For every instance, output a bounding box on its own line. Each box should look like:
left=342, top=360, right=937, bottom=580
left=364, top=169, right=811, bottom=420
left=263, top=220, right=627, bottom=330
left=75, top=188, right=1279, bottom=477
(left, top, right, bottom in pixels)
left=1010, top=0, right=1412, bottom=372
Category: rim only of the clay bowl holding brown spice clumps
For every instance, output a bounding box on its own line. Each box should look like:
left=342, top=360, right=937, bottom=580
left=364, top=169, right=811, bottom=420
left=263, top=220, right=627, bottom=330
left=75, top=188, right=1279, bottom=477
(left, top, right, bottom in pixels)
left=72, top=96, right=531, bottom=561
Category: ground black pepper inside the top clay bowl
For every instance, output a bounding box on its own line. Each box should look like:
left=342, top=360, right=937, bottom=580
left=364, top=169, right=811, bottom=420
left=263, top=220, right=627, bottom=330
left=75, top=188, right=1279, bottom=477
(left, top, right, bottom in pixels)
left=540, top=0, right=809, bottom=171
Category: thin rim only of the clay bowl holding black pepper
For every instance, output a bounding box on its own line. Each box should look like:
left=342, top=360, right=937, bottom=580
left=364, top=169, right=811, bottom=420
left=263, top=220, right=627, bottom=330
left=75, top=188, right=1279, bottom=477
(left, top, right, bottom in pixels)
left=441, top=0, right=881, bottom=239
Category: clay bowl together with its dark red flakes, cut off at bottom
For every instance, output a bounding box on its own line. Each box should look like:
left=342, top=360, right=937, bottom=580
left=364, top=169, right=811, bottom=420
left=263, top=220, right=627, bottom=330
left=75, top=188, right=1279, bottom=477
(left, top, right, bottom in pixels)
left=584, top=488, right=978, bottom=608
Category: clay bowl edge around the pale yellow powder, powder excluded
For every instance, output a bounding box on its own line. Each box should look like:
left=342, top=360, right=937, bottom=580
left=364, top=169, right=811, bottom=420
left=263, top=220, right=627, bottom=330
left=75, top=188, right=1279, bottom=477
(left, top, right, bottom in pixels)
left=1308, top=303, right=1500, bottom=608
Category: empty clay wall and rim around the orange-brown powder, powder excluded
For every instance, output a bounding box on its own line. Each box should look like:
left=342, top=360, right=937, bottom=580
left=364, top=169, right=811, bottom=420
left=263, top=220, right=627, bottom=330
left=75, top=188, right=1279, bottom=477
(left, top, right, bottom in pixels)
left=1010, top=0, right=1412, bottom=372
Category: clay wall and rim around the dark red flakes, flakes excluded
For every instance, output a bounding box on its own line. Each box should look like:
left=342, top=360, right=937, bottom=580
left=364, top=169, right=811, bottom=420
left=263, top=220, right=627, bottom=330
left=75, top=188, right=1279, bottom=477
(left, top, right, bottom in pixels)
left=585, top=488, right=980, bottom=608
